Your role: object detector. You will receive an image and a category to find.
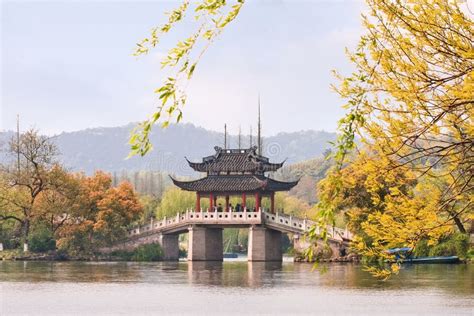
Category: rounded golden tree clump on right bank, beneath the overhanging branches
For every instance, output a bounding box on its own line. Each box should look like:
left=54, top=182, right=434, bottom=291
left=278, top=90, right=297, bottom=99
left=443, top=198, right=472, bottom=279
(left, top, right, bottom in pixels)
left=318, top=151, right=453, bottom=277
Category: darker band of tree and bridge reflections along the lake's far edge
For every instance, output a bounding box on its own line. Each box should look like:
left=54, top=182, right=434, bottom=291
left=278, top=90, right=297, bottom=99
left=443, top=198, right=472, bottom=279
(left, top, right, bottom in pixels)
left=0, top=261, right=474, bottom=295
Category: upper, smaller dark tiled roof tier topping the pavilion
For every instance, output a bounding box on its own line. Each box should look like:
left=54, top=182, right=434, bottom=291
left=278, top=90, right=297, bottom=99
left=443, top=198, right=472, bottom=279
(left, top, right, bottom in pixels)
left=186, top=146, right=284, bottom=174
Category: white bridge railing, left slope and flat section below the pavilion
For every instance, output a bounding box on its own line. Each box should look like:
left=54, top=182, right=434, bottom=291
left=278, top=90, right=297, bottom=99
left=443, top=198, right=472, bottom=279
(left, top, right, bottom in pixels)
left=128, top=210, right=262, bottom=236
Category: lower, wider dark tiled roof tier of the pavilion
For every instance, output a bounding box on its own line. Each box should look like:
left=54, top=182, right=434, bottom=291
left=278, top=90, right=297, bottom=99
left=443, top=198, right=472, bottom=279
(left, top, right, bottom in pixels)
left=170, top=174, right=298, bottom=192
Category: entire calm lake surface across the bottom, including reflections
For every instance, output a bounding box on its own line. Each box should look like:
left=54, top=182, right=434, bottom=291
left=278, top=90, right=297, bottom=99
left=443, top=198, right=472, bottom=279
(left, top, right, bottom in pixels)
left=0, top=260, right=474, bottom=315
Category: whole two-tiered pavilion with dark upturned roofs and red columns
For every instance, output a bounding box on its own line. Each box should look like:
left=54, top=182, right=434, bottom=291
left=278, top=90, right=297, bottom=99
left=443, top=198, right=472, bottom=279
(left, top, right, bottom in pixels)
left=171, top=146, right=298, bottom=213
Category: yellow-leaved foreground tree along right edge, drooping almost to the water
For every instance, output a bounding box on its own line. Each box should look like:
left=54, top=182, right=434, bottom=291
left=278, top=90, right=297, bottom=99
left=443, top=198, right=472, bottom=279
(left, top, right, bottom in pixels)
left=320, top=0, right=474, bottom=274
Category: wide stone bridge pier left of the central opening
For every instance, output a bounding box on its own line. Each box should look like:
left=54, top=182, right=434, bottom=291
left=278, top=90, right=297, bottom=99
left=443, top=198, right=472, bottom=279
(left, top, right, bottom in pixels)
left=188, top=225, right=224, bottom=261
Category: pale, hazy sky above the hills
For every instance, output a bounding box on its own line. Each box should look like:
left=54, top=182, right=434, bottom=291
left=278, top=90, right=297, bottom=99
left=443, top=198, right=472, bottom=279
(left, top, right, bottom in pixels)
left=0, top=0, right=364, bottom=136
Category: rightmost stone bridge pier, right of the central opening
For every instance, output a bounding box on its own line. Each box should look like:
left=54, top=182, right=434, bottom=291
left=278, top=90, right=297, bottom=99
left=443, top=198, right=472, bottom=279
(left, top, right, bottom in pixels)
left=248, top=225, right=283, bottom=261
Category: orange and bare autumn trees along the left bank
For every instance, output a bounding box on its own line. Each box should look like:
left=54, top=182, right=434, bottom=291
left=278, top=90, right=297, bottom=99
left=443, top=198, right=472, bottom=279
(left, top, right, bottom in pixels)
left=0, top=130, right=143, bottom=254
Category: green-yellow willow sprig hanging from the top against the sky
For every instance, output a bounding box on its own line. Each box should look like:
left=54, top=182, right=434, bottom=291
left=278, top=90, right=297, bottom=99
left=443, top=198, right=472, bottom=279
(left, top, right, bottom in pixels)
left=129, top=0, right=244, bottom=157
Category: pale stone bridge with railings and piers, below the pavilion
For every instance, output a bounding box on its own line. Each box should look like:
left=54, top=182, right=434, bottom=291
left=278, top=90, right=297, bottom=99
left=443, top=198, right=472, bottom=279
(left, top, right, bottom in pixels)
left=108, top=209, right=352, bottom=261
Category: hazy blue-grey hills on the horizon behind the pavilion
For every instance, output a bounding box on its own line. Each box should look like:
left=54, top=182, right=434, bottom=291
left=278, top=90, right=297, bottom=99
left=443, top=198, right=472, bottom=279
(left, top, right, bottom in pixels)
left=0, top=124, right=336, bottom=176
